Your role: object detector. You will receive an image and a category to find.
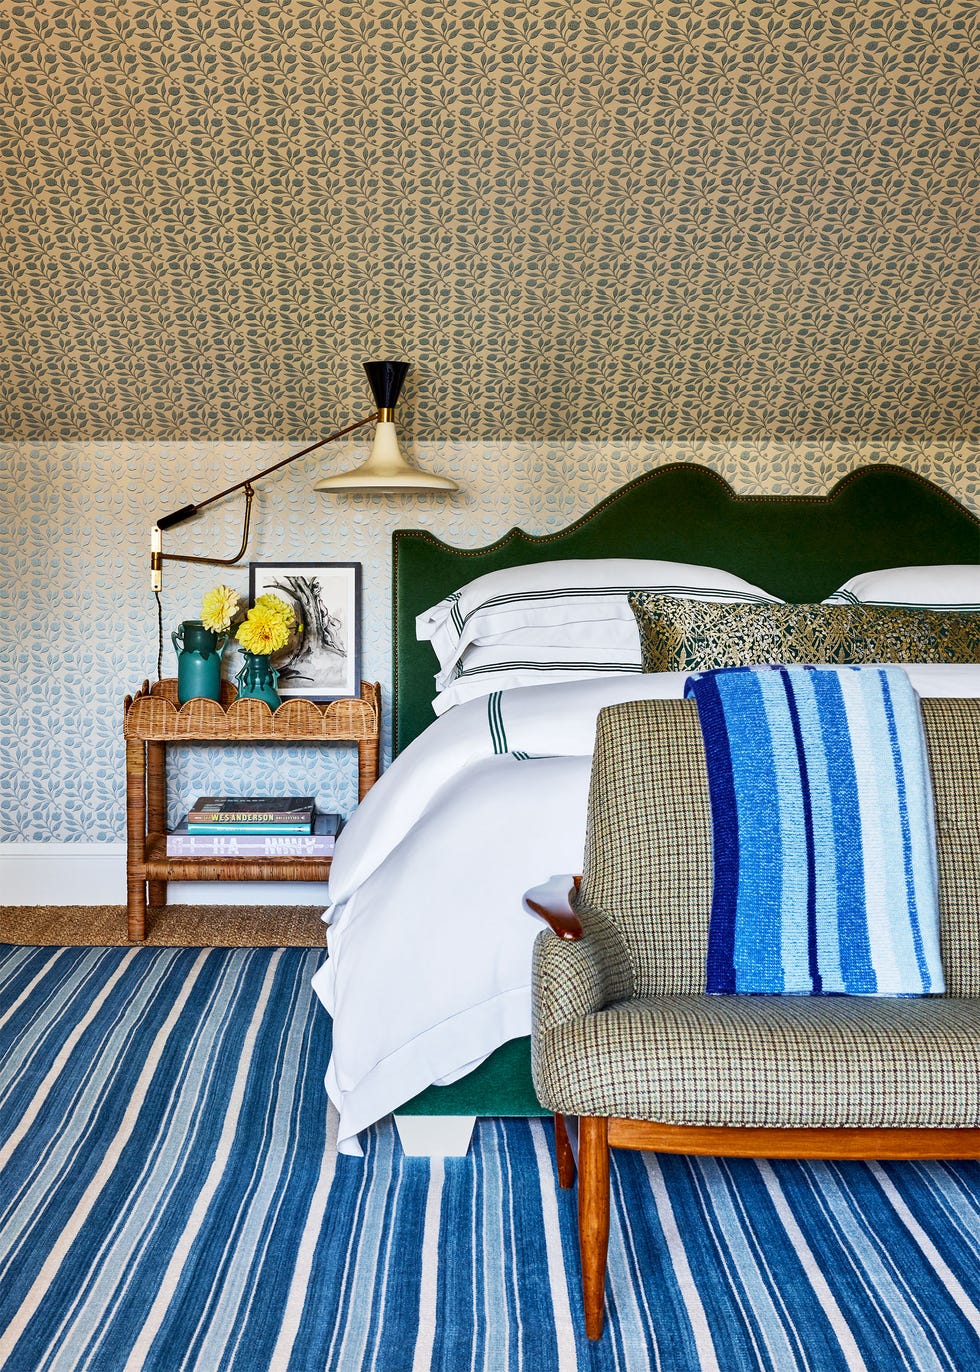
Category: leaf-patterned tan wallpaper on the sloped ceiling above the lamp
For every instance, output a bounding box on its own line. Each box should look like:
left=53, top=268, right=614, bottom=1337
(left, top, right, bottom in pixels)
left=0, top=0, right=980, bottom=442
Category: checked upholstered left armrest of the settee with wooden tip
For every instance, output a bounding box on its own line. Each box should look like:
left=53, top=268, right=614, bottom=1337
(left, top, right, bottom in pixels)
left=524, top=877, right=633, bottom=1032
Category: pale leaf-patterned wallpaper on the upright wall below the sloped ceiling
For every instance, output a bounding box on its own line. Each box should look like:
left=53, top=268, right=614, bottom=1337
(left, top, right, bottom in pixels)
left=0, top=440, right=980, bottom=841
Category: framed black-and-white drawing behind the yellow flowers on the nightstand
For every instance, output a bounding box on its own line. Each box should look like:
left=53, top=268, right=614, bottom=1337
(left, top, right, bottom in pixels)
left=248, top=563, right=361, bottom=700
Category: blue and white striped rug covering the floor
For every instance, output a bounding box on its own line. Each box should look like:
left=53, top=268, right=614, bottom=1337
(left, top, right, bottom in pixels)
left=0, top=948, right=980, bottom=1372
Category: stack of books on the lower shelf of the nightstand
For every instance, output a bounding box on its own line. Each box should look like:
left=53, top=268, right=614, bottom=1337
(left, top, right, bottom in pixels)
left=166, top=796, right=343, bottom=858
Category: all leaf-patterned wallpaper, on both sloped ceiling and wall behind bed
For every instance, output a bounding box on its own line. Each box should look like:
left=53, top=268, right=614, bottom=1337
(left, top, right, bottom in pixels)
left=0, top=0, right=980, bottom=841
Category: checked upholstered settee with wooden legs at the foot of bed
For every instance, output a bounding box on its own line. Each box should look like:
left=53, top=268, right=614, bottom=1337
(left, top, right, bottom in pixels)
left=526, top=700, right=980, bottom=1339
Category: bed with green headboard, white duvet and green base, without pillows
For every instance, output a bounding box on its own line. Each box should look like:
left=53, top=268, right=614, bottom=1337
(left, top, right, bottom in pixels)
left=314, top=464, right=980, bottom=1152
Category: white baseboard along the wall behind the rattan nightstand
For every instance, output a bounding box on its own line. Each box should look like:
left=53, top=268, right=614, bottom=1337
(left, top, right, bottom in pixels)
left=0, top=842, right=327, bottom=906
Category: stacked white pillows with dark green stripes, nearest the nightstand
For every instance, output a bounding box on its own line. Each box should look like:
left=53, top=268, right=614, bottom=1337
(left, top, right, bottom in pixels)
left=416, top=557, right=780, bottom=715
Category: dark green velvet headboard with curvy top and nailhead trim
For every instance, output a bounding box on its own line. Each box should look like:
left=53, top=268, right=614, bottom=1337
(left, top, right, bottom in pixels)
left=393, top=462, right=980, bottom=750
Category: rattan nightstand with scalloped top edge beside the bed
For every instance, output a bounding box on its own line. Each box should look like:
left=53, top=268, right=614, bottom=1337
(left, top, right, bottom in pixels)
left=122, top=678, right=382, bottom=943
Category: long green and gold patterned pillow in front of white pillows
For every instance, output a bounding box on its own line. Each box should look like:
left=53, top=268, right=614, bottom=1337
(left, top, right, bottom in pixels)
left=629, top=591, right=980, bottom=672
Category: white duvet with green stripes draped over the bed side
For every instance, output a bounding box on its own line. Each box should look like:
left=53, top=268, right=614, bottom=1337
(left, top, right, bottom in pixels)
left=313, top=665, right=980, bottom=1154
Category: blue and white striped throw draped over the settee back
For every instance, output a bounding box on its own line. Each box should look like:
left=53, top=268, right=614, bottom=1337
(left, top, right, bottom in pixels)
left=685, top=667, right=944, bottom=996
